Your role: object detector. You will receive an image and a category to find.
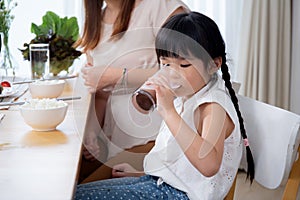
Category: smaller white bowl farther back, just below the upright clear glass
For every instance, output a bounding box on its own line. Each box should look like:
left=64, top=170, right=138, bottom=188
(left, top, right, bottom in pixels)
left=29, top=80, right=65, bottom=98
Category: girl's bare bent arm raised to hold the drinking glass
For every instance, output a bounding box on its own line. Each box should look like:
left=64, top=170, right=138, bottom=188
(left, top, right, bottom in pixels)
left=156, top=86, right=234, bottom=177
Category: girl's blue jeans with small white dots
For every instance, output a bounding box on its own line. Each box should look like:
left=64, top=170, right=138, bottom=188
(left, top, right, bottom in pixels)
left=75, top=175, right=189, bottom=200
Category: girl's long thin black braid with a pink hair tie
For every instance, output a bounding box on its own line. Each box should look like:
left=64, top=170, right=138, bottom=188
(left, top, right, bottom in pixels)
left=221, top=55, right=255, bottom=183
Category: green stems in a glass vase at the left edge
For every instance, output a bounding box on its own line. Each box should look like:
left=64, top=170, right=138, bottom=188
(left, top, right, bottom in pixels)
left=0, top=0, right=17, bottom=75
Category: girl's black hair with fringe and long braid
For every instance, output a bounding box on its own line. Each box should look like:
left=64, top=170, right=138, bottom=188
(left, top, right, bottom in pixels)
left=155, top=12, right=255, bottom=183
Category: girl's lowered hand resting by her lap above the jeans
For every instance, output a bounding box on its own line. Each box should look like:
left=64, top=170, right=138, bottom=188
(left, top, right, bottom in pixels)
left=112, top=163, right=144, bottom=178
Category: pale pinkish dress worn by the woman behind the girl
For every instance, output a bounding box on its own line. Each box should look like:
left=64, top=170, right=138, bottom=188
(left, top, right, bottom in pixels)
left=89, top=0, right=188, bottom=159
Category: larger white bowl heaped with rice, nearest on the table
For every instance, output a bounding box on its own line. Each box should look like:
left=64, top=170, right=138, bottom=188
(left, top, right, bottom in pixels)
left=19, top=99, right=68, bottom=131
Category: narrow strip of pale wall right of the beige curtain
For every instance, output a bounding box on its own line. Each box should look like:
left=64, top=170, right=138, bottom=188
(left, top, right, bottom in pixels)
left=290, top=0, right=300, bottom=114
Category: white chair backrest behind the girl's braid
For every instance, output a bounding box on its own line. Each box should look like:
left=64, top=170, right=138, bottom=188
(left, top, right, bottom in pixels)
left=238, top=95, right=300, bottom=189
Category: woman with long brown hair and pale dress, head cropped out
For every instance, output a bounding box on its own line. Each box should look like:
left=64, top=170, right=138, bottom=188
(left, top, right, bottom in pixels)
left=77, top=0, right=188, bottom=182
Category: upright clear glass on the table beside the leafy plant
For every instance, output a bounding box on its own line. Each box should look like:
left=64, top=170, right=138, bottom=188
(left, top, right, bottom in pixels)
left=29, top=43, right=50, bottom=79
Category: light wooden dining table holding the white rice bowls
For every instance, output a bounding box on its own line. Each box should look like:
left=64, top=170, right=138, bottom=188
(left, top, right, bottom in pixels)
left=0, top=77, right=90, bottom=200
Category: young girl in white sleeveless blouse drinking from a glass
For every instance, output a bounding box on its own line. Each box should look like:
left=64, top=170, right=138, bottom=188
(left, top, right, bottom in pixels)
left=76, top=12, right=254, bottom=200
